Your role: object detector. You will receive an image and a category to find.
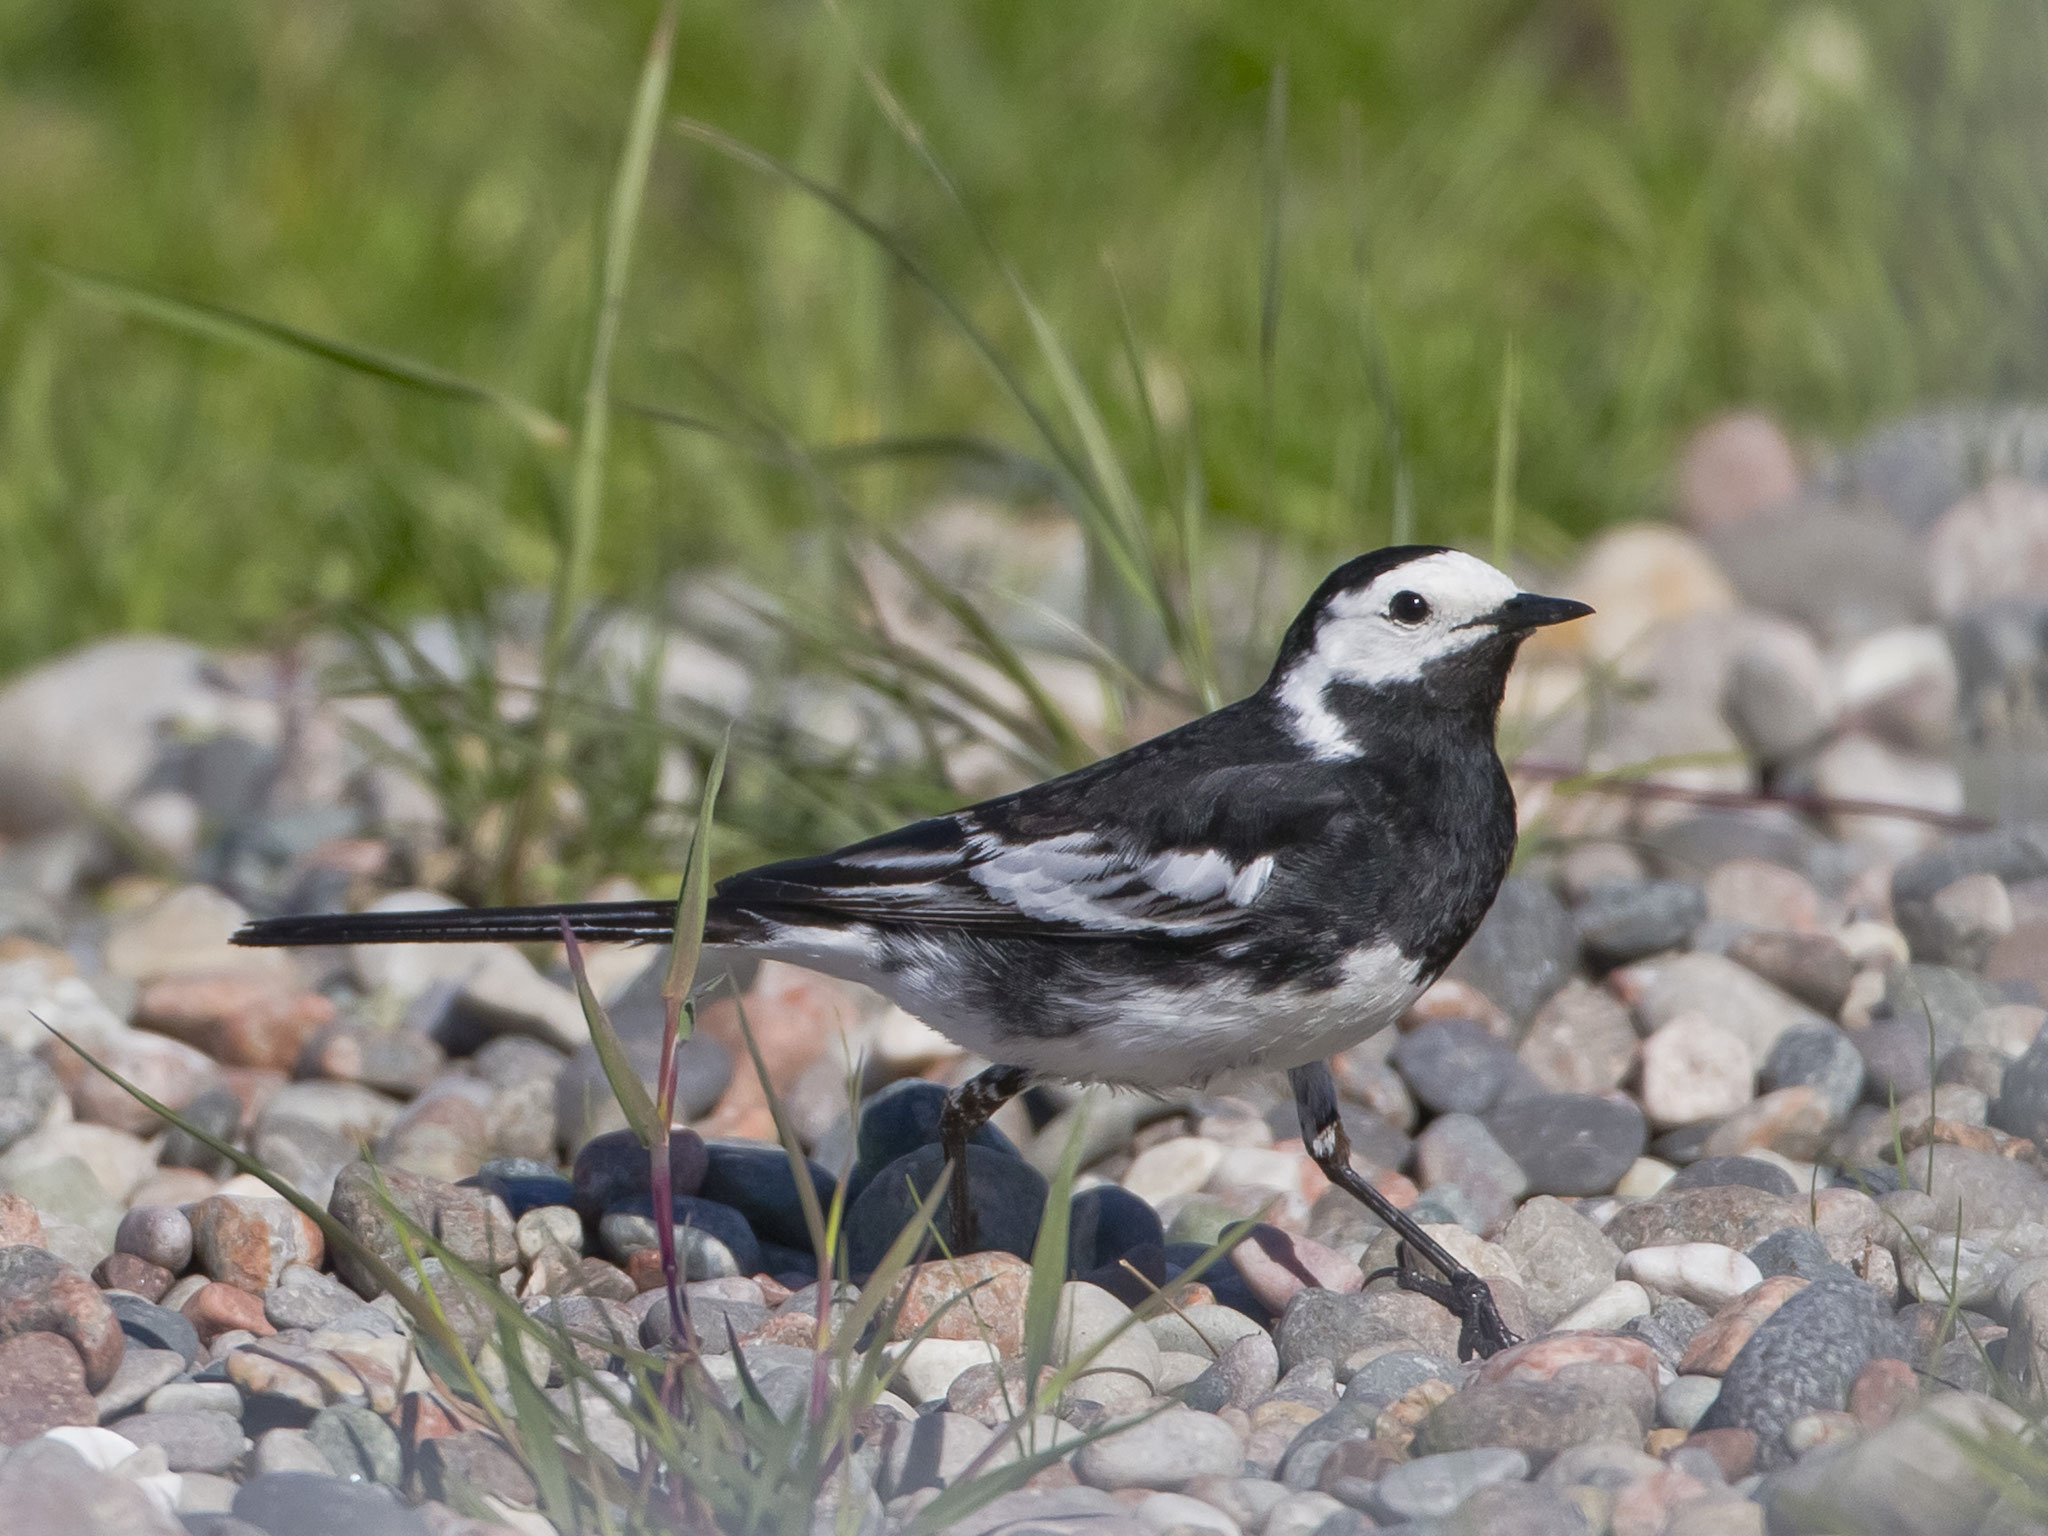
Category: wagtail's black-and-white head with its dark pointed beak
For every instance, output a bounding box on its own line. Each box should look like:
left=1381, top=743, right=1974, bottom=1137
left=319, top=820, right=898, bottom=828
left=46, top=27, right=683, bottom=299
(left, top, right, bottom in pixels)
left=1266, top=545, right=1591, bottom=758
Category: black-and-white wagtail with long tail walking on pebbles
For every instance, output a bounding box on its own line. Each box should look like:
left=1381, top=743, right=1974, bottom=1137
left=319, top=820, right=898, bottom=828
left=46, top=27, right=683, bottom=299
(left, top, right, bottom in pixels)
left=236, top=545, right=1591, bottom=1358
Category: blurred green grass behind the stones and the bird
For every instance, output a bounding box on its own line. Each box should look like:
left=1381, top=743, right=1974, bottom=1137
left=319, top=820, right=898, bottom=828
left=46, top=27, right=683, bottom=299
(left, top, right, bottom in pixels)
left=0, top=0, right=2048, bottom=668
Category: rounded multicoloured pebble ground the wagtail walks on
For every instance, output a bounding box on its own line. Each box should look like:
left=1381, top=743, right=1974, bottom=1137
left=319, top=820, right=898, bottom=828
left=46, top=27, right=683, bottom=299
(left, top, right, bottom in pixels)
left=0, top=416, right=2048, bottom=1536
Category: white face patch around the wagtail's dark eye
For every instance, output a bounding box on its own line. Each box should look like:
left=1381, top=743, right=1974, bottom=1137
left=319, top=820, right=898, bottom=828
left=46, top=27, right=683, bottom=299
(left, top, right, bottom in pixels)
left=1280, top=549, right=1520, bottom=760
